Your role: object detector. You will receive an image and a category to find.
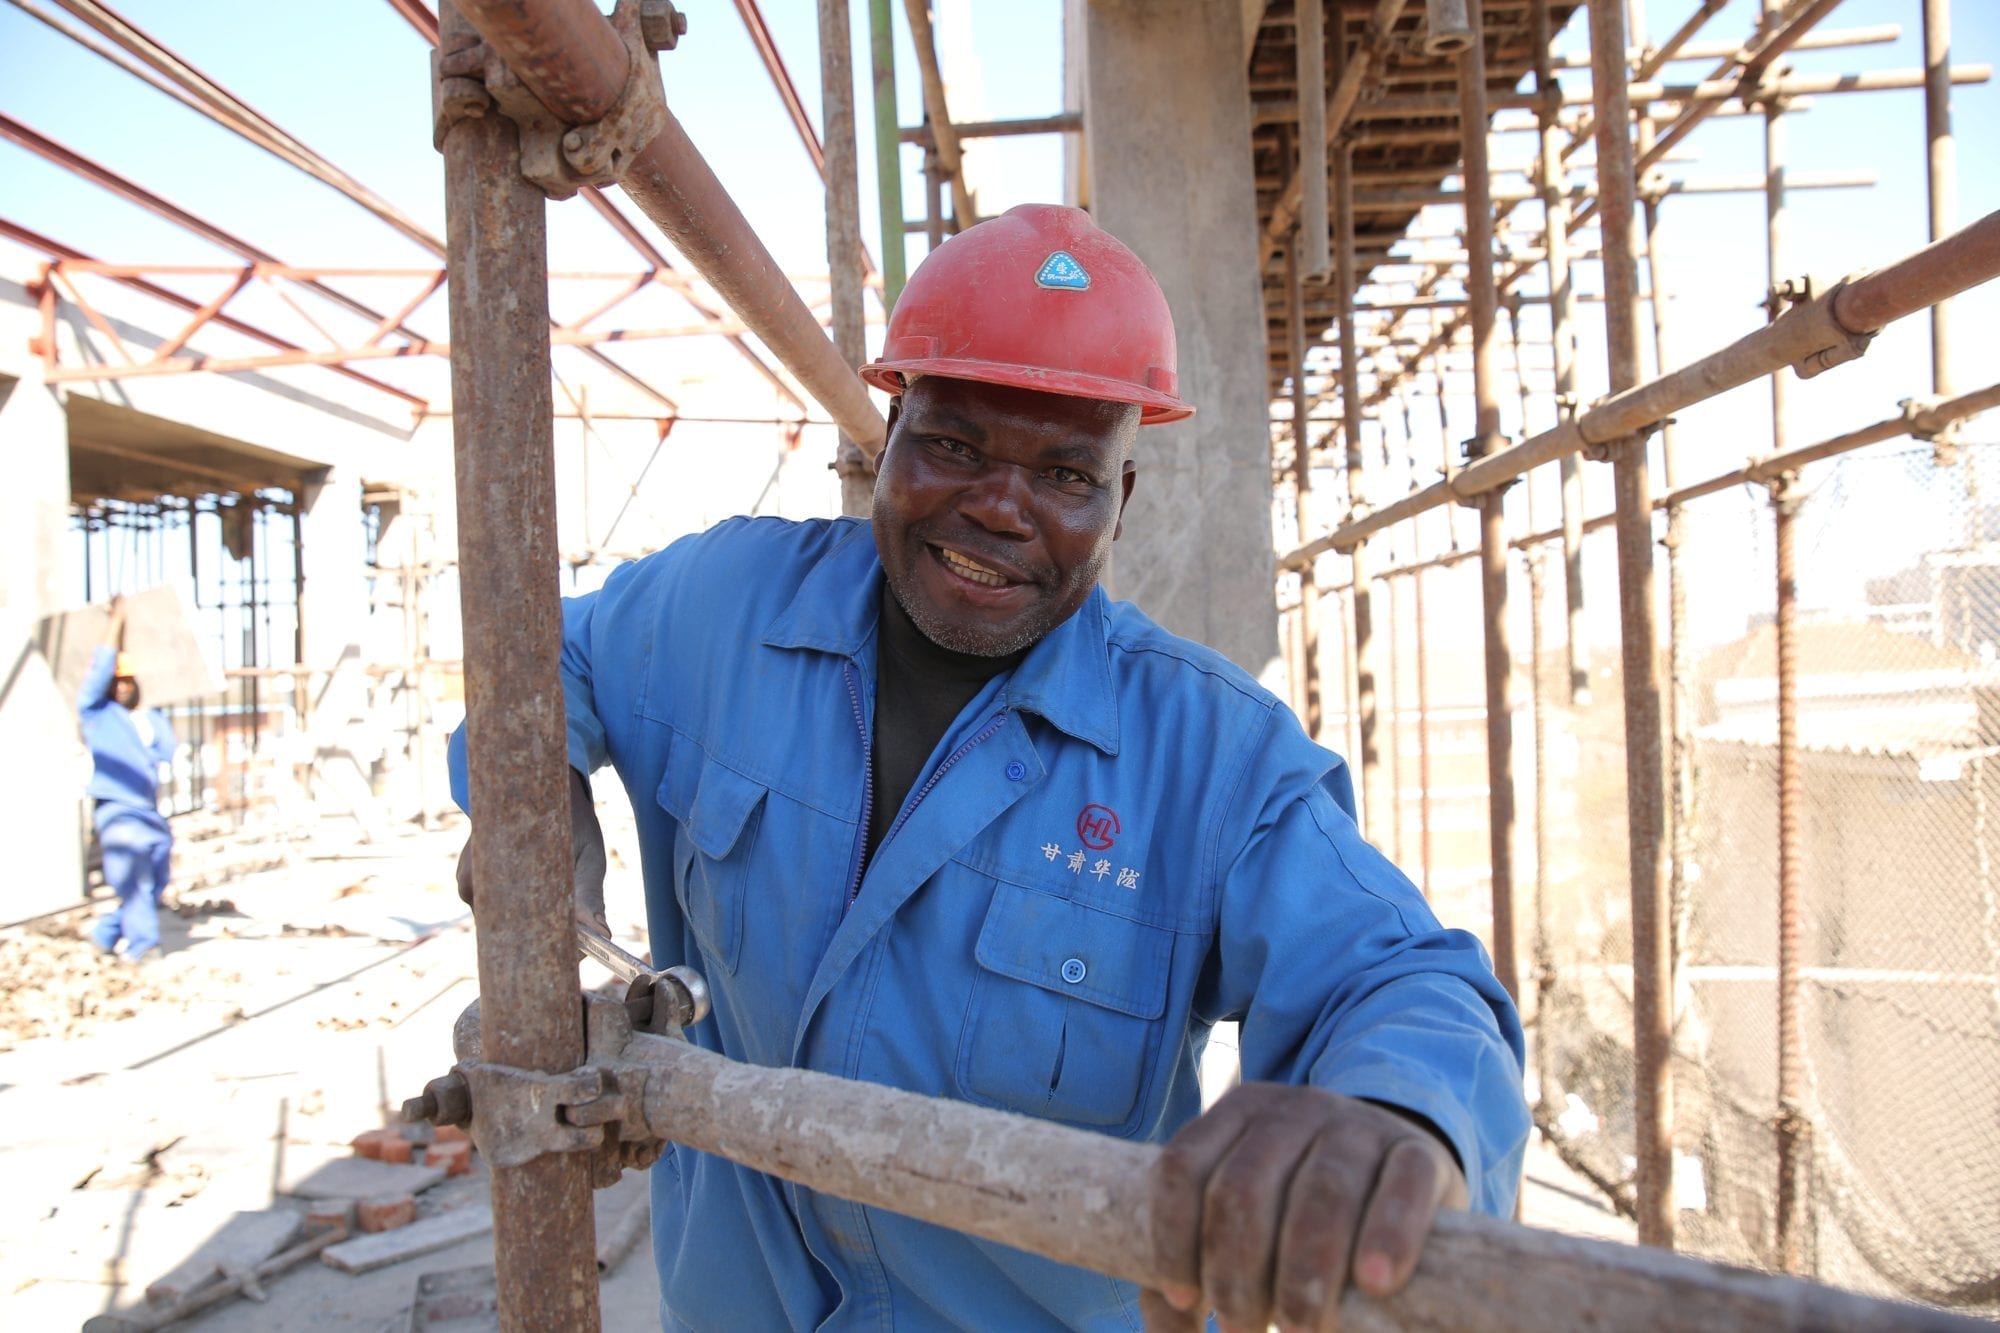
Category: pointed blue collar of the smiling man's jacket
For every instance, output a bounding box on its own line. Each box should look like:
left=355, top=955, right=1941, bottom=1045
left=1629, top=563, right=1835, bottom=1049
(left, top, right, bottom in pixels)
left=764, top=522, right=1118, bottom=755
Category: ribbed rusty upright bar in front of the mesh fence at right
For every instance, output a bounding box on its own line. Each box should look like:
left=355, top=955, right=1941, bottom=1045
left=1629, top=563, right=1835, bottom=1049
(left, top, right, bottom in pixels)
left=1770, top=474, right=1812, bottom=1273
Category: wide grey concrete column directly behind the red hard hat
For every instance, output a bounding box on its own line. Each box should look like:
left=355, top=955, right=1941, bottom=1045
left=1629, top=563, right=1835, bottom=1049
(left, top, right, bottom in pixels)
left=1084, top=0, right=1278, bottom=673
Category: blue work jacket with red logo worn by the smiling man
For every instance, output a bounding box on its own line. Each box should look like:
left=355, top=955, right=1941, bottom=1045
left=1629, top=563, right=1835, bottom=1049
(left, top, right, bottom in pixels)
left=452, top=518, right=1528, bottom=1329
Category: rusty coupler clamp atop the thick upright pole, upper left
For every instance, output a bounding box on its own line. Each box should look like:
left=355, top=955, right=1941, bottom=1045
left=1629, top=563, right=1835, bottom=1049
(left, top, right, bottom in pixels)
left=430, top=0, right=688, bottom=198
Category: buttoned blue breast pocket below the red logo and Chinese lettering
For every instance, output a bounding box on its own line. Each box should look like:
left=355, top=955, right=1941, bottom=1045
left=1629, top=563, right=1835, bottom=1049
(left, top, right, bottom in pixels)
left=958, top=883, right=1174, bottom=1133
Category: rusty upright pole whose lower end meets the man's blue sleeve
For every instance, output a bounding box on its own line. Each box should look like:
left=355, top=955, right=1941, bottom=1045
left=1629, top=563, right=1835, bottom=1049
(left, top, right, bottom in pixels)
left=1458, top=0, right=1520, bottom=997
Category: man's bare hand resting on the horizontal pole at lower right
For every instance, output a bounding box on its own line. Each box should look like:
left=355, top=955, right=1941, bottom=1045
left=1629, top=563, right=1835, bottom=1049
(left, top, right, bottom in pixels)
left=1140, top=1083, right=1468, bottom=1333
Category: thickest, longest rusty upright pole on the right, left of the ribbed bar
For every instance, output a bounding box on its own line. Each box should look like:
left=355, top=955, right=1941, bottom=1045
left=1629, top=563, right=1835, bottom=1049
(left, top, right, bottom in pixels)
left=1590, top=4, right=1674, bottom=1247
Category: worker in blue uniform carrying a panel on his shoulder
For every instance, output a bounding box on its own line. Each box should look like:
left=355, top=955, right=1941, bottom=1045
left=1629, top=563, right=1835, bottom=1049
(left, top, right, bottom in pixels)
left=76, top=602, right=174, bottom=963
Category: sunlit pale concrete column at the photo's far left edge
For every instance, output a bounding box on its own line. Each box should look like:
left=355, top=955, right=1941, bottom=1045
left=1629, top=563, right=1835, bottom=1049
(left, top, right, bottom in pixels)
left=0, top=374, right=90, bottom=923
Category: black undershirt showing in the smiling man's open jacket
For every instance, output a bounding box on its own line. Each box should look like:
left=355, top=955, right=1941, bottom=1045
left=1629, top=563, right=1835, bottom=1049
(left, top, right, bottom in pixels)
left=868, top=582, right=1028, bottom=859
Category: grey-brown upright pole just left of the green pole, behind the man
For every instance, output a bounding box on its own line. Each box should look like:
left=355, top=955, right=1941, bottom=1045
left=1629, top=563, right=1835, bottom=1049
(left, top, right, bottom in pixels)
left=820, top=0, right=872, bottom=518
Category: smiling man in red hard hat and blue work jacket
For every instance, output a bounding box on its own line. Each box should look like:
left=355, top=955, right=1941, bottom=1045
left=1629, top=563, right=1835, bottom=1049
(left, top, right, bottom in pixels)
left=454, top=206, right=1528, bottom=1329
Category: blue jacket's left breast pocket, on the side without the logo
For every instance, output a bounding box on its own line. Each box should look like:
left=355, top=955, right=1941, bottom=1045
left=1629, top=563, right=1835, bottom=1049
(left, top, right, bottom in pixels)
left=656, top=747, right=768, bottom=973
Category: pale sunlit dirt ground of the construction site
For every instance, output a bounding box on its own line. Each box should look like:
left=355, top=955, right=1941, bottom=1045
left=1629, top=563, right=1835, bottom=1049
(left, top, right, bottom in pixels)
left=0, top=809, right=1630, bottom=1333
